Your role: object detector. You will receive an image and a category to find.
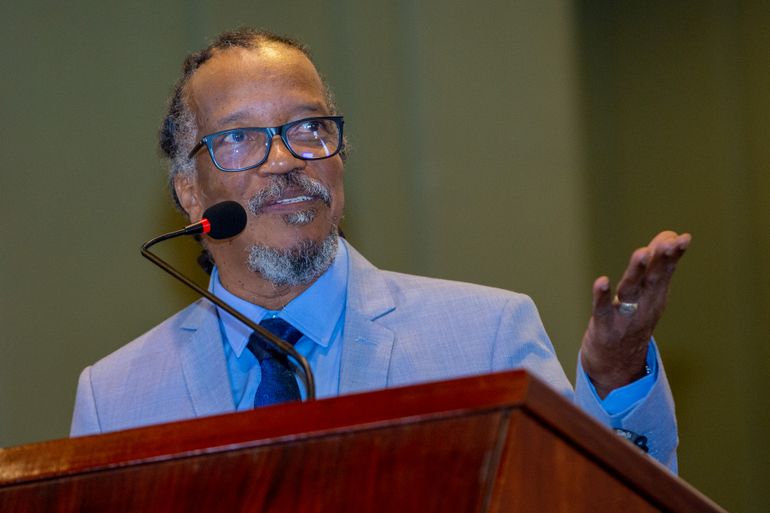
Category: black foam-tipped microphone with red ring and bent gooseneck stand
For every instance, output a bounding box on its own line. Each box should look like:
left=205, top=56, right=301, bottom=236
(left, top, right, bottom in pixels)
left=141, top=201, right=315, bottom=401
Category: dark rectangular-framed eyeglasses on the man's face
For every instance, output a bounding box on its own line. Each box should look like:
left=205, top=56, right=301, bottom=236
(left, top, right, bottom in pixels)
left=187, top=116, right=344, bottom=172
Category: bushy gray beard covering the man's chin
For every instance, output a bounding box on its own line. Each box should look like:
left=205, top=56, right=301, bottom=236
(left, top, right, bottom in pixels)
left=248, top=229, right=339, bottom=287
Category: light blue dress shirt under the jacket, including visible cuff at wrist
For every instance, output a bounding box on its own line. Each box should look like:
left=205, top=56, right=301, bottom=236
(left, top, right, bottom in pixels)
left=209, top=241, right=658, bottom=420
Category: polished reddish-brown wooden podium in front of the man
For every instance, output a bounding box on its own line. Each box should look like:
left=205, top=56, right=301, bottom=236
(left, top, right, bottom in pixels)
left=0, top=371, right=723, bottom=513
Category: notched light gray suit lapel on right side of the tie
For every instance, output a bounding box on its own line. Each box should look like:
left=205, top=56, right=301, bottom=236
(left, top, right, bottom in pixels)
left=340, top=244, right=396, bottom=394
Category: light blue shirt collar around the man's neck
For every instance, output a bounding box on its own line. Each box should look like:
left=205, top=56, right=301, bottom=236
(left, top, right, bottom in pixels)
left=209, top=240, right=348, bottom=358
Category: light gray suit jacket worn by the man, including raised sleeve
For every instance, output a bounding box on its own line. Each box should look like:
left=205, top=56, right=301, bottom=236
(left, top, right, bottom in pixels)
left=71, top=246, right=677, bottom=469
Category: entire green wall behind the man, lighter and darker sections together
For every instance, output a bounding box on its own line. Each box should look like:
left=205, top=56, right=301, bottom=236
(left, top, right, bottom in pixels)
left=0, top=0, right=770, bottom=511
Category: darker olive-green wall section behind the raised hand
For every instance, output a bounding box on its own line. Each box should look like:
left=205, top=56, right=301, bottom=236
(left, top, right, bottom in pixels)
left=576, top=0, right=770, bottom=512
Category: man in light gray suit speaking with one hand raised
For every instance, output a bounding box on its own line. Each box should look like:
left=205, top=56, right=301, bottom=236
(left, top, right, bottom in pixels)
left=72, top=30, right=690, bottom=469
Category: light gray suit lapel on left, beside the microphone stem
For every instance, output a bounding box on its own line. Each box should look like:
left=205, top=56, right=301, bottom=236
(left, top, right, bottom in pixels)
left=180, top=299, right=235, bottom=417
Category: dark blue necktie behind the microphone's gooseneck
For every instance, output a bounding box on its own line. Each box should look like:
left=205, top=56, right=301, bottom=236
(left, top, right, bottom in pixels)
left=248, top=317, right=302, bottom=408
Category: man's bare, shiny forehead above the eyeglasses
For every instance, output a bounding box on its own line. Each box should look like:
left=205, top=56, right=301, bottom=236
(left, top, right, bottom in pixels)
left=186, top=44, right=330, bottom=133
